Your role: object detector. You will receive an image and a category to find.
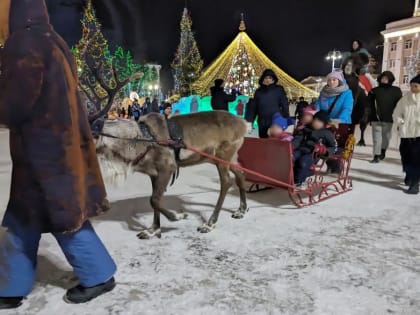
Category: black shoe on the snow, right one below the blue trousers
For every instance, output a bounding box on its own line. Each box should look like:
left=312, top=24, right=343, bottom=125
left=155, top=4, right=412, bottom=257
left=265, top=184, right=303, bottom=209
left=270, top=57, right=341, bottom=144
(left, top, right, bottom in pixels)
left=64, top=277, right=115, bottom=304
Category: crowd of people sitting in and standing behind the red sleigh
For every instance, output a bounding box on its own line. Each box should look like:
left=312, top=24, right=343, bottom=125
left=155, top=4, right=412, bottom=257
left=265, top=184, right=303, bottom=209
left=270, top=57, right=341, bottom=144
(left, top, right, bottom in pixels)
left=211, top=40, right=420, bottom=194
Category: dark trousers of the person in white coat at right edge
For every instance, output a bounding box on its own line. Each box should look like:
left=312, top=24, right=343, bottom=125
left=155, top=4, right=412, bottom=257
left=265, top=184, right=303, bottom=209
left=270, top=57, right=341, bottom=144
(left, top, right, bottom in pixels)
left=400, top=138, right=420, bottom=182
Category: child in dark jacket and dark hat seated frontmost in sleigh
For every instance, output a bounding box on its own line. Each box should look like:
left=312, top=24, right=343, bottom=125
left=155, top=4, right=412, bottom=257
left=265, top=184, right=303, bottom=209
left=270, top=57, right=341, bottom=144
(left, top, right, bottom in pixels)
left=293, top=111, right=337, bottom=187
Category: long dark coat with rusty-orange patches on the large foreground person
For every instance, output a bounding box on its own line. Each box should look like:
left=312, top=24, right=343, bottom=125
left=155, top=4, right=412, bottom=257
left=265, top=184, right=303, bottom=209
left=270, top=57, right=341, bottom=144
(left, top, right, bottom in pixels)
left=0, top=0, right=109, bottom=233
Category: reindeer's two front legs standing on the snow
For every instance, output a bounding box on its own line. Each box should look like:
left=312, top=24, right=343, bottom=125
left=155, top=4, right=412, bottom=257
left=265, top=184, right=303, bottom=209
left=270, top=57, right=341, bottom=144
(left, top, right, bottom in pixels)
left=137, top=172, right=187, bottom=239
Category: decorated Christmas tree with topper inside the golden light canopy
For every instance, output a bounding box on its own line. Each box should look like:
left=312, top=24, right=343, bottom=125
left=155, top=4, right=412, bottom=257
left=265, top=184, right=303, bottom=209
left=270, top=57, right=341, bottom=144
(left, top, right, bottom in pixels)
left=225, top=16, right=258, bottom=96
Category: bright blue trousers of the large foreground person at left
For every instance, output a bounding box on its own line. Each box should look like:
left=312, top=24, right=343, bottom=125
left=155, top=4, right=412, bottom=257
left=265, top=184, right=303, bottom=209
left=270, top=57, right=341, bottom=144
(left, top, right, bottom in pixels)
left=0, top=212, right=116, bottom=297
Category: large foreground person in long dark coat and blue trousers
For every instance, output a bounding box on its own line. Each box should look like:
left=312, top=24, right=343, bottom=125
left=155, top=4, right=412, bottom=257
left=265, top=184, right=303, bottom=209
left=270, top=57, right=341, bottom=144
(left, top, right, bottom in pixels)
left=0, top=0, right=116, bottom=309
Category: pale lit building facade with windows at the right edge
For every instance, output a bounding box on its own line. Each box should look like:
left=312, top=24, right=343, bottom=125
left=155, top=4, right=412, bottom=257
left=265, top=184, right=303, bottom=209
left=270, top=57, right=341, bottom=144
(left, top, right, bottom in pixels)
left=381, top=0, right=420, bottom=91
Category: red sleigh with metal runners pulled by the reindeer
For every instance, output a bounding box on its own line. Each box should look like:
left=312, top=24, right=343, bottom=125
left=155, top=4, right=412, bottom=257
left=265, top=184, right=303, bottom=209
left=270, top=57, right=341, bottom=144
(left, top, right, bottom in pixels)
left=238, top=125, right=355, bottom=208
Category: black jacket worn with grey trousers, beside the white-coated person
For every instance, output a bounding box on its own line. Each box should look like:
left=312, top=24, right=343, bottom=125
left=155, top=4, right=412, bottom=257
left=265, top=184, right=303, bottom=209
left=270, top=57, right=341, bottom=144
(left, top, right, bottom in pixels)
left=369, top=84, right=402, bottom=123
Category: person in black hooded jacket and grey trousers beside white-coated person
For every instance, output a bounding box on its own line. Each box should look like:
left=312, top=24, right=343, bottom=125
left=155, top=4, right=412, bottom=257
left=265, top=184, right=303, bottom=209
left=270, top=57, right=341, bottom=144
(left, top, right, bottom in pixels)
left=369, top=71, right=402, bottom=163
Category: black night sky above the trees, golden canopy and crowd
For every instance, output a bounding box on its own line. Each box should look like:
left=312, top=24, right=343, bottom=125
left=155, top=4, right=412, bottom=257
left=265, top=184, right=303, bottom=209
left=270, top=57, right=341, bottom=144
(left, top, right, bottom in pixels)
left=47, top=0, right=415, bottom=92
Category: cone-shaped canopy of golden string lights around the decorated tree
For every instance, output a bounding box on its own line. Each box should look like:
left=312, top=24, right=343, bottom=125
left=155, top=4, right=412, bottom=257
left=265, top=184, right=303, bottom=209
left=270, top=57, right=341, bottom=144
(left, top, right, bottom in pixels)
left=194, top=31, right=319, bottom=98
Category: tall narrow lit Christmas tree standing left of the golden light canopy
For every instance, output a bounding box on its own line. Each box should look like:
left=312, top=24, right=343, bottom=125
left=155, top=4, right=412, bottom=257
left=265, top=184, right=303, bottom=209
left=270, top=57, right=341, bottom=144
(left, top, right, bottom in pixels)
left=172, top=8, right=203, bottom=96
